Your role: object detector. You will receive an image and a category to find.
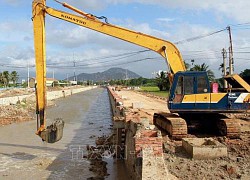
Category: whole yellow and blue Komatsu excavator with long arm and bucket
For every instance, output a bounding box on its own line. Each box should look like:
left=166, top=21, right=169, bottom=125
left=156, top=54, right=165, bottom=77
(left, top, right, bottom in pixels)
left=32, top=0, right=250, bottom=143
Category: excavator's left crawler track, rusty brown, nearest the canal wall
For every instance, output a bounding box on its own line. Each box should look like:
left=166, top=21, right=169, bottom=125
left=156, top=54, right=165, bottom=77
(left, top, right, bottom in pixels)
left=154, top=113, right=187, bottom=139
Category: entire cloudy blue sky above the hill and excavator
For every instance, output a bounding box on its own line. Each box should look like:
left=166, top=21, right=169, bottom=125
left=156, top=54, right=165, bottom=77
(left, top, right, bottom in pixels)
left=0, top=0, right=250, bottom=79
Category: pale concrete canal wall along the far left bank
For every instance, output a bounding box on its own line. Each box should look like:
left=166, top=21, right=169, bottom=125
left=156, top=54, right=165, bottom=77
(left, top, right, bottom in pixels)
left=0, top=86, right=97, bottom=105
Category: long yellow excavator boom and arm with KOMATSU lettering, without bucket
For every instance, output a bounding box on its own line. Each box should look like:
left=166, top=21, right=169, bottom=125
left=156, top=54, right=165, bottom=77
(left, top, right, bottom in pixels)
left=32, top=0, right=186, bottom=141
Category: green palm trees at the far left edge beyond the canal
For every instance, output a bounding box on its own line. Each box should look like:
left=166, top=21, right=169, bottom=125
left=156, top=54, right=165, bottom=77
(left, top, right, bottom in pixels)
left=0, top=71, right=19, bottom=87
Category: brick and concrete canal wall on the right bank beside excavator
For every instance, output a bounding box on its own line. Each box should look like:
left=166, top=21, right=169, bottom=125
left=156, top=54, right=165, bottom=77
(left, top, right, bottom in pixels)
left=107, top=87, right=175, bottom=180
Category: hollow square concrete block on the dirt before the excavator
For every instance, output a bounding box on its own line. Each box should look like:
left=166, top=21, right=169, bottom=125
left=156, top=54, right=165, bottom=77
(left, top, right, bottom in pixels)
left=182, top=138, right=227, bottom=159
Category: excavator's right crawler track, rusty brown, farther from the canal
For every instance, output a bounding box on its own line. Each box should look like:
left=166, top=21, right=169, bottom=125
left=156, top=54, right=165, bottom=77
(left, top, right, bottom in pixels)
left=217, top=118, right=241, bottom=138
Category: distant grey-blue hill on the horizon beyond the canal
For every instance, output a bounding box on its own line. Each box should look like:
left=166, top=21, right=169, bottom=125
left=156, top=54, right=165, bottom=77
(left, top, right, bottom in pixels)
left=69, top=68, right=141, bottom=82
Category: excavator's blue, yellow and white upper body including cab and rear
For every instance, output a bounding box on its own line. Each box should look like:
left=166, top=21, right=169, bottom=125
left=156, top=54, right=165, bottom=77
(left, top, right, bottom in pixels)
left=168, top=71, right=250, bottom=114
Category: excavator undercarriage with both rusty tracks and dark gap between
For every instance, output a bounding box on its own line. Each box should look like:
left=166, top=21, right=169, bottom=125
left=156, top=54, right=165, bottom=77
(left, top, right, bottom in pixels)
left=154, top=112, right=240, bottom=140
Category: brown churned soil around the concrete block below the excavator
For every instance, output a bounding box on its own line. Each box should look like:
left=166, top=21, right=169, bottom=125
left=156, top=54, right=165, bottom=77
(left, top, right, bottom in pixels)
left=164, top=120, right=250, bottom=179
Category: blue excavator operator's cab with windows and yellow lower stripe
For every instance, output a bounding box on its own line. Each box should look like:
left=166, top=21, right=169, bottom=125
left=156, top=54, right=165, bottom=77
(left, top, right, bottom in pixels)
left=168, top=71, right=211, bottom=112
